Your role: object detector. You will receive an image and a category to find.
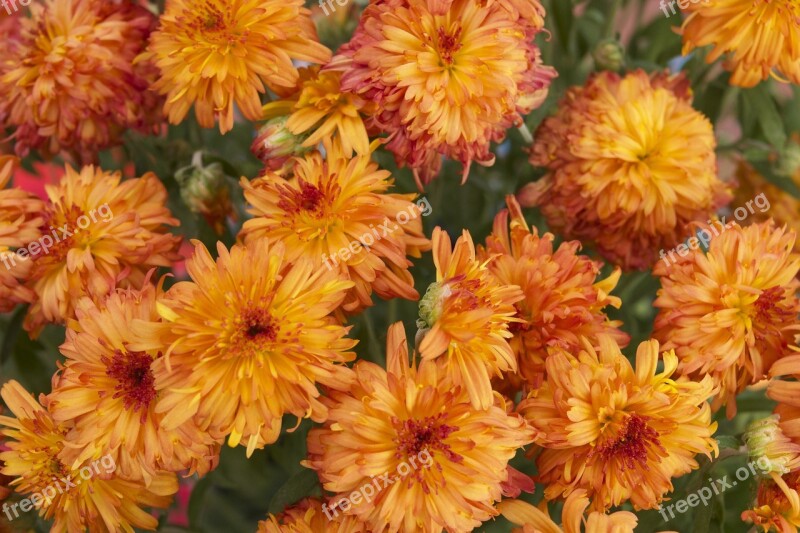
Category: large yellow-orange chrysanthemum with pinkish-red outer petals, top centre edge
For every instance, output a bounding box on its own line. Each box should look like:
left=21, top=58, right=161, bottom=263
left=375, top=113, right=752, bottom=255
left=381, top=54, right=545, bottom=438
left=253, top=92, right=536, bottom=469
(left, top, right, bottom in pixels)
left=330, top=0, right=555, bottom=187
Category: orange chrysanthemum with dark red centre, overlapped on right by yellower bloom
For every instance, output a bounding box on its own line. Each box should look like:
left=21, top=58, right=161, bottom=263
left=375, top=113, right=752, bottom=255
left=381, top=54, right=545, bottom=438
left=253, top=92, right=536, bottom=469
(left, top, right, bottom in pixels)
left=48, top=283, right=219, bottom=485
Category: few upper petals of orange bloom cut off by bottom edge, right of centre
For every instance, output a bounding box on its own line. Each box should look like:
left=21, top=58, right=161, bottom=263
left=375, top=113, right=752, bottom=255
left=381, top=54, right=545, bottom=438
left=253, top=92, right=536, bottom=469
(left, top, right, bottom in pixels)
left=497, top=489, right=639, bottom=533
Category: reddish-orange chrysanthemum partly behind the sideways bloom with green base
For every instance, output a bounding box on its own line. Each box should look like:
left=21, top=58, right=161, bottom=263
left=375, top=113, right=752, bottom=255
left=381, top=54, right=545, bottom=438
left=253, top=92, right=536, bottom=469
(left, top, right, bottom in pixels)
left=478, top=196, right=630, bottom=387
